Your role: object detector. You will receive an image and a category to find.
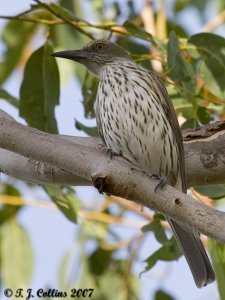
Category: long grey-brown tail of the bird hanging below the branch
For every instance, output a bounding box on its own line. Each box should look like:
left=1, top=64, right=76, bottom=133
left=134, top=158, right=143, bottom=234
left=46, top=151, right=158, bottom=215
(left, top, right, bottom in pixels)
left=167, top=218, right=215, bottom=288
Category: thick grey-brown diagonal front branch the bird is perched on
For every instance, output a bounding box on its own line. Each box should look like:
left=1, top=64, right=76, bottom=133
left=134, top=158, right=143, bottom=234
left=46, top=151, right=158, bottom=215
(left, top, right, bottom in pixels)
left=0, top=113, right=225, bottom=242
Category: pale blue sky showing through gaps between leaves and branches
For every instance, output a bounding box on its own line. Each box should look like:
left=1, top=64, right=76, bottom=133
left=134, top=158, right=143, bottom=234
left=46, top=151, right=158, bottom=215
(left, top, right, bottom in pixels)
left=0, top=0, right=221, bottom=300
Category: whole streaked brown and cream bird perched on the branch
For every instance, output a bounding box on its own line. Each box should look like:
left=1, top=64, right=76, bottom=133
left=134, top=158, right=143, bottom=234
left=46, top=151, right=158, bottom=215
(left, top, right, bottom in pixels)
left=52, top=39, right=215, bottom=288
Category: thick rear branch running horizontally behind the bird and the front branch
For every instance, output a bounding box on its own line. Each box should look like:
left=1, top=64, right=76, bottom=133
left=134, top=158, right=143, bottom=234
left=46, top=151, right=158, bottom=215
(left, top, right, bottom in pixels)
left=0, top=115, right=225, bottom=186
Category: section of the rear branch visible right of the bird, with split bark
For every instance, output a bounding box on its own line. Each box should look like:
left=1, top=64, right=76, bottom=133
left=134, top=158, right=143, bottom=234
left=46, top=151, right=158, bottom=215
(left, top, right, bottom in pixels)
left=183, top=121, right=225, bottom=186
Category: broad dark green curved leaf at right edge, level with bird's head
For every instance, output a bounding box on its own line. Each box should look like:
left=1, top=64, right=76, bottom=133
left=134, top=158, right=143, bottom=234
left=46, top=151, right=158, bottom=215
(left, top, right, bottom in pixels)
left=188, top=33, right=225, bottom=98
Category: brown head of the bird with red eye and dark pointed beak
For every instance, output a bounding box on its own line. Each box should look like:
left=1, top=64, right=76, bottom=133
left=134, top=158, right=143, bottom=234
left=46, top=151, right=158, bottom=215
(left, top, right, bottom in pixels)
left=52, top=40, right=131, bottom=75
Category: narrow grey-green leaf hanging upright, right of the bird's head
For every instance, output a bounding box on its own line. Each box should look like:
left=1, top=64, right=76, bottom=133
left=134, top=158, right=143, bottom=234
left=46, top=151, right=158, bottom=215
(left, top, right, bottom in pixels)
left=167, top=31, right=196, bottom=93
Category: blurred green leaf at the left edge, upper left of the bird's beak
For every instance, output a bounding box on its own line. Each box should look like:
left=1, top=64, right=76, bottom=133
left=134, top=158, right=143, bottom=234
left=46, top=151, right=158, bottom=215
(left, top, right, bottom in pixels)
left=0, top=20, right=36, bottom=84
